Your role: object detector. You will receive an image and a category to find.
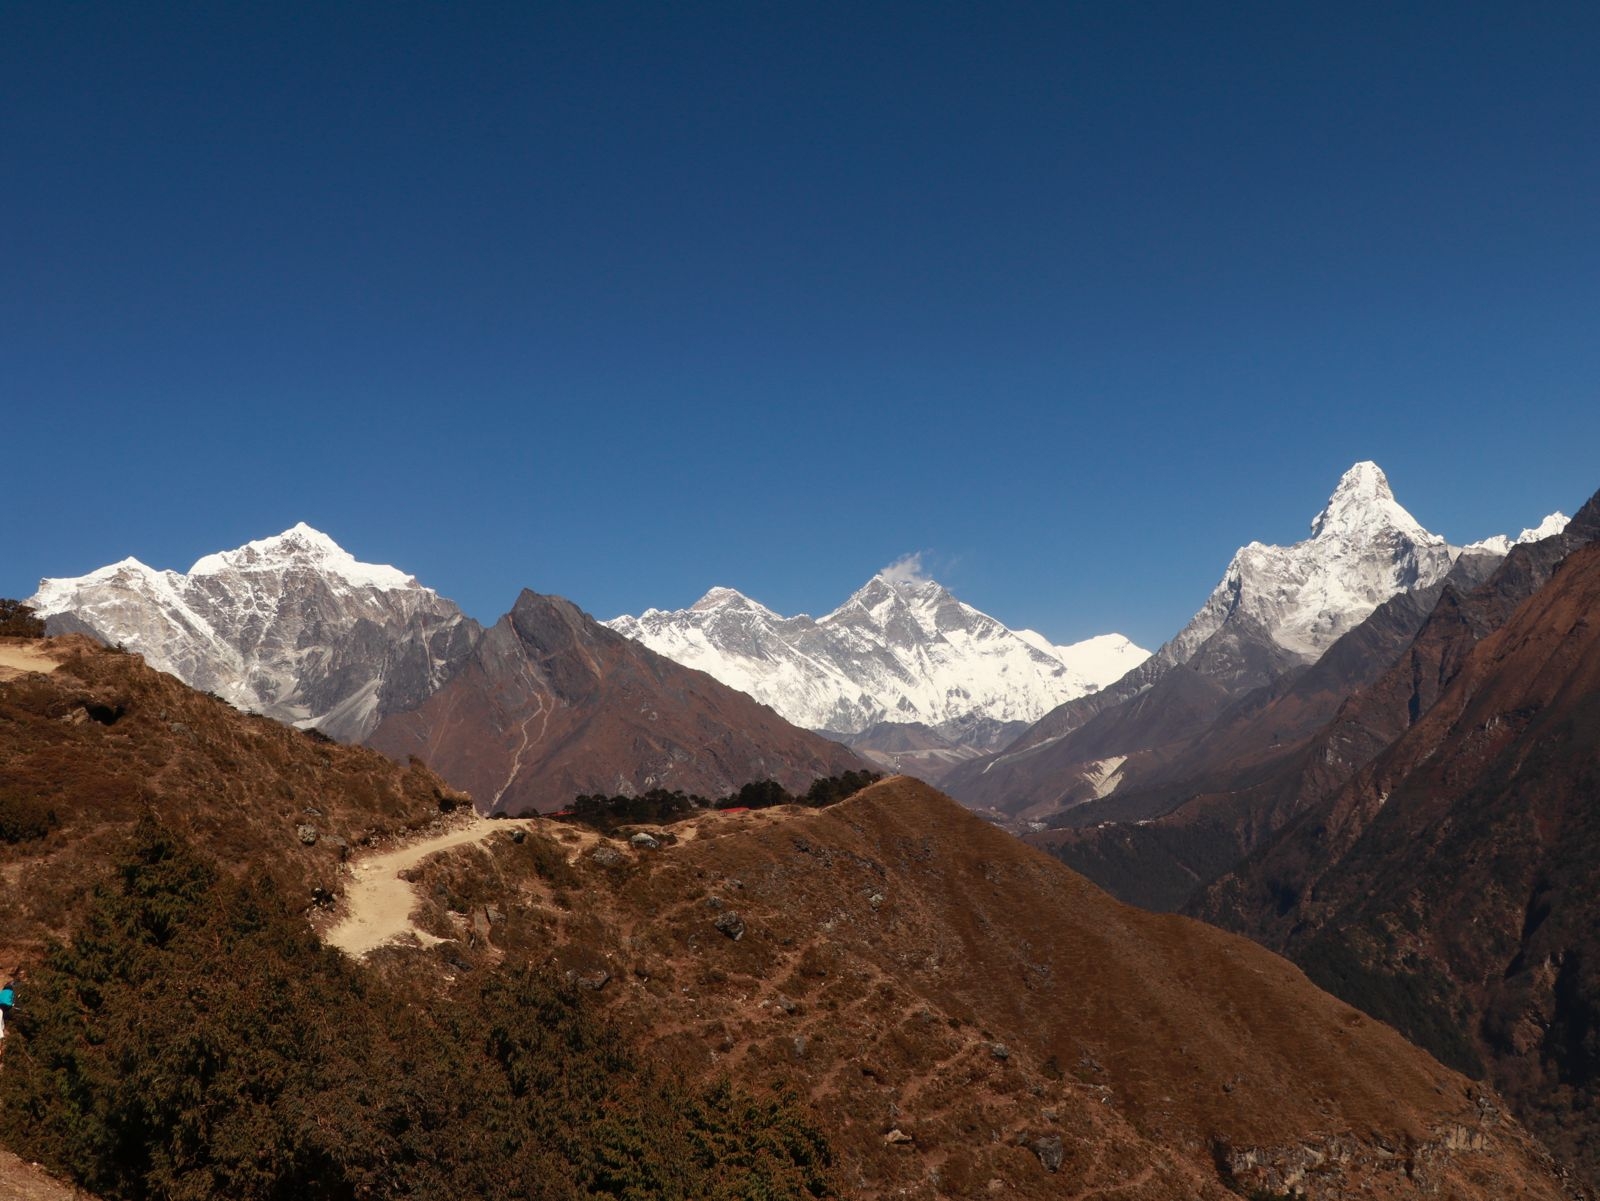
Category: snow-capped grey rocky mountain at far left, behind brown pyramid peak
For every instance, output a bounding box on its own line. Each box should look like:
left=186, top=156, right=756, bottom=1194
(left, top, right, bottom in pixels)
left=29, top=525, right=480, bottom=742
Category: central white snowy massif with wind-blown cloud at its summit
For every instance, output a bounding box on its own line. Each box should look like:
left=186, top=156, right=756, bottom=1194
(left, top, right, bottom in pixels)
left=606, top=569, right=1149, bottom=734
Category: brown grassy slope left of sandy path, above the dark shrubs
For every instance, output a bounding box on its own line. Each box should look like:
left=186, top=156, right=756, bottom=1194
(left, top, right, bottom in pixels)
left=0, top=635, right=464, bottom=971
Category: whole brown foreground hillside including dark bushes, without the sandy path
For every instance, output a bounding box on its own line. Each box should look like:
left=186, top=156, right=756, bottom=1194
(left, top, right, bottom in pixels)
left=0, top=649, right=1576, bottom=1201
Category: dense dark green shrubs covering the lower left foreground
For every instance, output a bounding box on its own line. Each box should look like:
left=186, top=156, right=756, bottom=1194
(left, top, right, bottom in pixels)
left=0, top=820, right=830, bottom=1201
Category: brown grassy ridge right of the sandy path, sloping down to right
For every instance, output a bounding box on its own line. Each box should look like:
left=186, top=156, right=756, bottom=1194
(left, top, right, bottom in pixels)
left=392, top=777, right=1562, bottom=1201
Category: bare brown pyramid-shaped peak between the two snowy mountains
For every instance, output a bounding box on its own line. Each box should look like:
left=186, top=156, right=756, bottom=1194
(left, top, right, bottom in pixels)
left=368, top=592, right=866, bottom=814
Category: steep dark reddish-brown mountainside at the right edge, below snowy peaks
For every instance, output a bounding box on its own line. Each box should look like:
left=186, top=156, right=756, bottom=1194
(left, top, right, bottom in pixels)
left=1195, top=502, right=1600, bottom=1180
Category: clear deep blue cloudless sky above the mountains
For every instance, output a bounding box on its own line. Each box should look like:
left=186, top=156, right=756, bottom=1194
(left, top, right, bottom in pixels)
left=0, top=0, right=1600, bottom=646
